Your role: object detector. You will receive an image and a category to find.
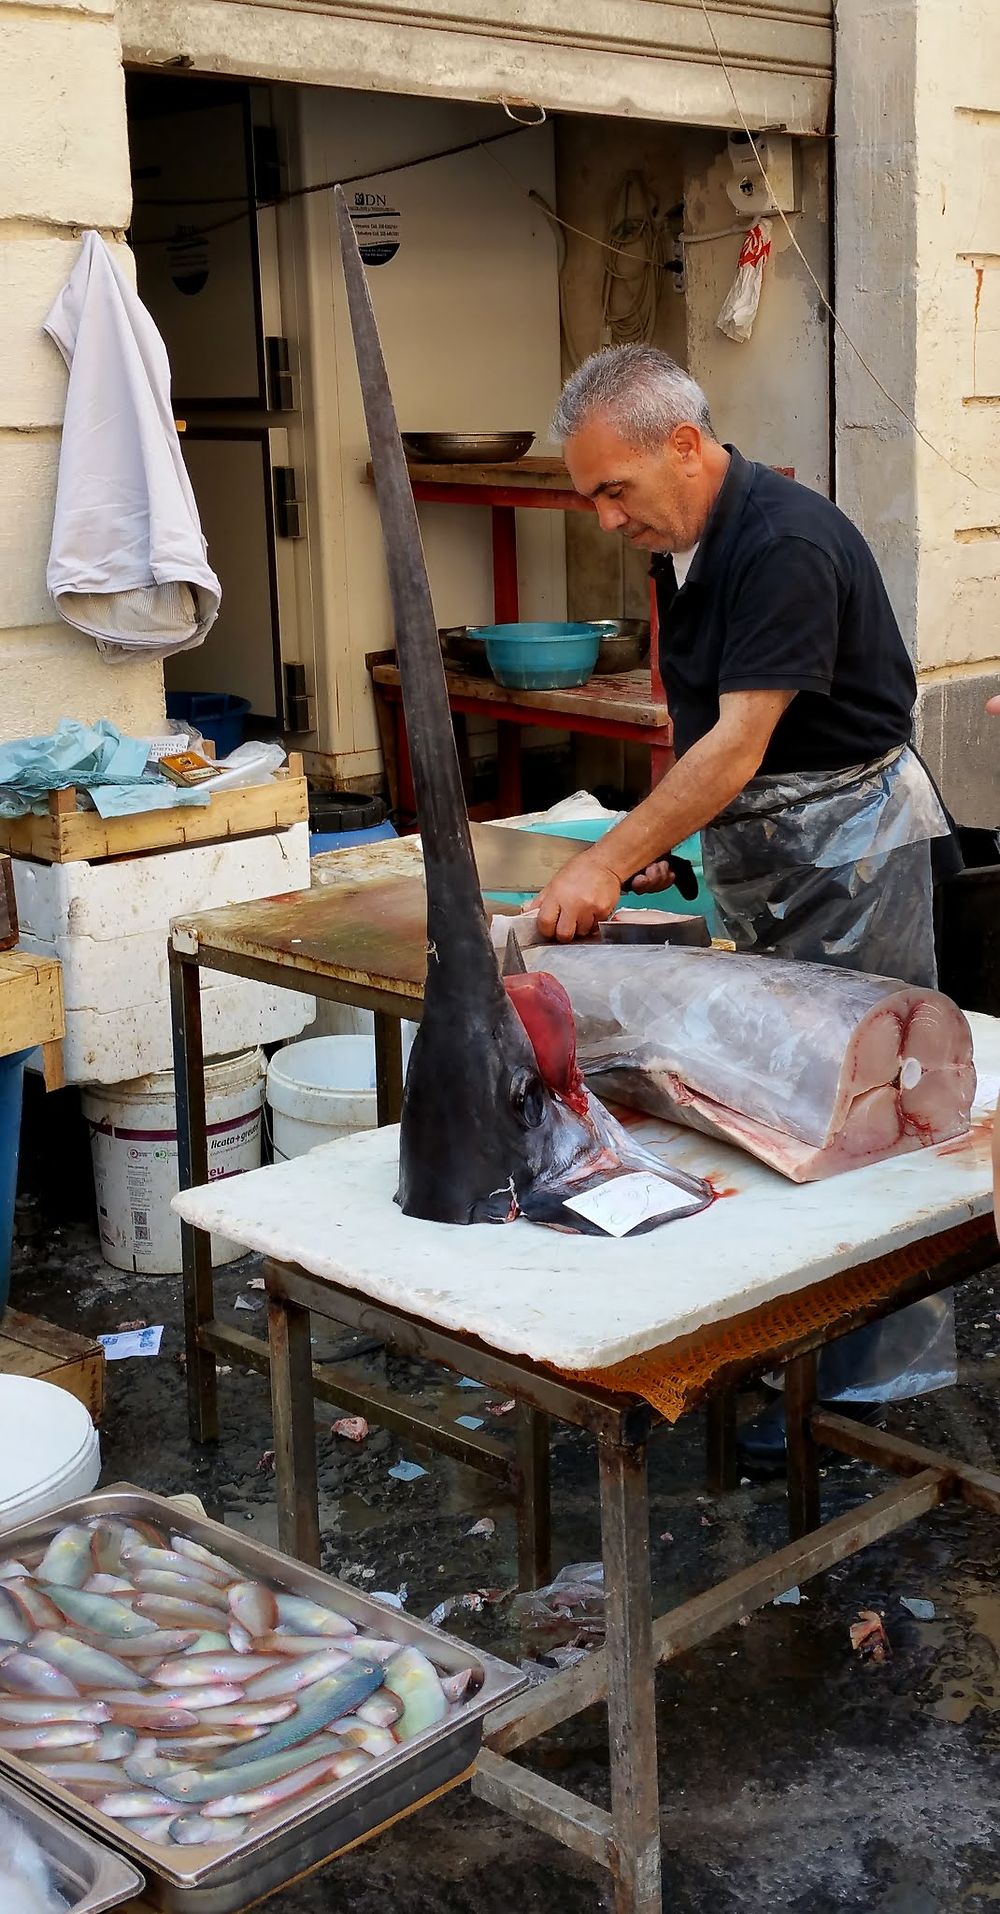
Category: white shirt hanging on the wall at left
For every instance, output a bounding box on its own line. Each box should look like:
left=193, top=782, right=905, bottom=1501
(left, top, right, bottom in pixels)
left=44, top=234, right=222, bottom=662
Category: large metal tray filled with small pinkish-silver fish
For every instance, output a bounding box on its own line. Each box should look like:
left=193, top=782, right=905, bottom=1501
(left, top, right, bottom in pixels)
left=0, top=1485, right=525, bottom=1914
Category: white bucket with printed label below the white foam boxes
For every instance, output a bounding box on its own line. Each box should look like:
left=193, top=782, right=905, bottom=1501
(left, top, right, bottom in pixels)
left=82, top=1051, right=264, bottom=1277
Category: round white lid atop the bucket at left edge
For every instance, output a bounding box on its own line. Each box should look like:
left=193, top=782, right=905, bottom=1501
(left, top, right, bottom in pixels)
left=0, top=1376, right=100, bottom=1520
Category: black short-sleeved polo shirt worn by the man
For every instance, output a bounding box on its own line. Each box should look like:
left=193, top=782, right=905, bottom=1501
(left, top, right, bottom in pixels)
left=651, top=446, right=916, bottom=773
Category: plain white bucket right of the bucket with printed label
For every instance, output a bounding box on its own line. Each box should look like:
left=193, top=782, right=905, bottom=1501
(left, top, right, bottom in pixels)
left=268, top=1035, right=377, bottom=1162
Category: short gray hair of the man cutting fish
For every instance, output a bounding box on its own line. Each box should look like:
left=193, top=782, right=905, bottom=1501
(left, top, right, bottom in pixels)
left=552, top=346, right=715, bottom=448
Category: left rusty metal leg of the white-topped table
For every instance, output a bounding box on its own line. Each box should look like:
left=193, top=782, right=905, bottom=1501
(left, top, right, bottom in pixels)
left=268, top=1296, right=320, bottom=1568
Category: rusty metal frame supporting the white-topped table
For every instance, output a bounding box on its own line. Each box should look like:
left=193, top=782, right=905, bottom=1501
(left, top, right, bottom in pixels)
left=264, top=1217, right=1000, bottom=1914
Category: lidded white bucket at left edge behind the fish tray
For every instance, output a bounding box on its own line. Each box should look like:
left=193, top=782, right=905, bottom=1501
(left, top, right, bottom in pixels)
left=0, top=1376, right=102, bottom=1531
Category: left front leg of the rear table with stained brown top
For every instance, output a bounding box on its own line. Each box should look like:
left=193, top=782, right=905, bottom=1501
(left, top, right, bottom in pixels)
left=170, top=946, right=218, bottom=1443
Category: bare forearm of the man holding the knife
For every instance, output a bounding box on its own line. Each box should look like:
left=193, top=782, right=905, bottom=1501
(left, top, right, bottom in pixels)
left=596, top=731, right=757, bottom=884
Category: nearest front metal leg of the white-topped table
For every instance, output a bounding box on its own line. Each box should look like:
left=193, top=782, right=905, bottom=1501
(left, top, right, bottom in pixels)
left=600, top=1441, right=663, bottom=1914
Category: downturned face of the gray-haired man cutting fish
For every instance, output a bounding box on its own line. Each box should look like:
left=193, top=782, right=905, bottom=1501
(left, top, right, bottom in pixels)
left=563, top=417, right=711, bottom=551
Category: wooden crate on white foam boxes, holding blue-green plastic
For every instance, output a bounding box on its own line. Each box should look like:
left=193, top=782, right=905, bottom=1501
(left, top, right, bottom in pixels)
left=0, top=756, right=308, bottom=863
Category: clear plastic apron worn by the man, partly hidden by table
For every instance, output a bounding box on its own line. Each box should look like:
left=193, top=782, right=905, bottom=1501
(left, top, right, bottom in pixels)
left=701, top=745, right=958, bottom=1401
